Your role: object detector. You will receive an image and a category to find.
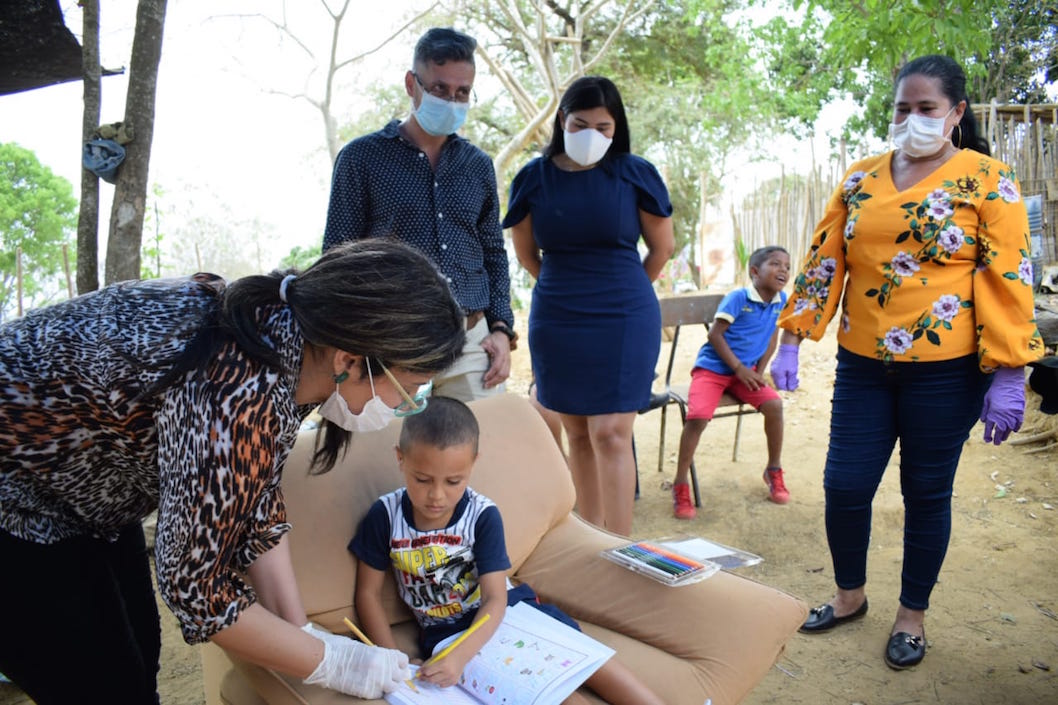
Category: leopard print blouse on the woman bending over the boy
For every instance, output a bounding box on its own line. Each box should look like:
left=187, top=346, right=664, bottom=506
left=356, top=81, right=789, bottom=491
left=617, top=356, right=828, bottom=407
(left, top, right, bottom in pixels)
left=0, top=274, right=311, bottom=644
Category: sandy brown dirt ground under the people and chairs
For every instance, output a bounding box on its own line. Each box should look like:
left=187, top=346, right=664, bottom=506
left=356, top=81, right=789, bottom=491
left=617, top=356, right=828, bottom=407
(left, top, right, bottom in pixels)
left=0, top=319, right=1058, bottom=705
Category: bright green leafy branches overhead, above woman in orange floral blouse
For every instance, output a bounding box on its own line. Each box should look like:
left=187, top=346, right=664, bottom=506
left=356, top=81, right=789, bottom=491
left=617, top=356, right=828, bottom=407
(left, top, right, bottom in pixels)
left=750, top=0, right=1058, bottom=138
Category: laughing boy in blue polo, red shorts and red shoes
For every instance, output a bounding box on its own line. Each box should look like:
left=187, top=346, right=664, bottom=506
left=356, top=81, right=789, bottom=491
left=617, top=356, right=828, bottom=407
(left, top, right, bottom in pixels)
left=672, top=246, right=790, bottom=519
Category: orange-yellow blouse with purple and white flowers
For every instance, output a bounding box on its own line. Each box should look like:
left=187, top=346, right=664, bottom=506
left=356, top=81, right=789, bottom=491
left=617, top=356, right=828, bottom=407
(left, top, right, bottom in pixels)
left=779, top=149, right=1044, bottom=372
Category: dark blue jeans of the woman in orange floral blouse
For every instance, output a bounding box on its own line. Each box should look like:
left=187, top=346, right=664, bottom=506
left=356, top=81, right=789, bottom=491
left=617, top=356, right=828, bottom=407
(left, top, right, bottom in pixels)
left=823, top=347, right=991, bottom=610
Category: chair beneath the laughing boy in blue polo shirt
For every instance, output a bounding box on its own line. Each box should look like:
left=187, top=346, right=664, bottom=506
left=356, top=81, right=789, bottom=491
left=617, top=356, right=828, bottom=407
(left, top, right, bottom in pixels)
left=639, top=294, right=756, bottom=507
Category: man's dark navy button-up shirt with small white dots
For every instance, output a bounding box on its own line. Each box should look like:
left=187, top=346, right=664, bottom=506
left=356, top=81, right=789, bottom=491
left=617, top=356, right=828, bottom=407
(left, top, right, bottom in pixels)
left=323, top=120, right=514, bottom=327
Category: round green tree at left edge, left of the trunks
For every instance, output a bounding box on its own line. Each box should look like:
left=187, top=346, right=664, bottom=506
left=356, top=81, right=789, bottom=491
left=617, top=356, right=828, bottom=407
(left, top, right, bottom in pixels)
left=0, top=142, right=77, bottom=320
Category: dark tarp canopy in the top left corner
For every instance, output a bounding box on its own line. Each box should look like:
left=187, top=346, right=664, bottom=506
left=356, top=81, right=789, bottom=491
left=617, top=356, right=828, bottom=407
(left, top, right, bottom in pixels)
left=0, top=0, right=81, bottom=94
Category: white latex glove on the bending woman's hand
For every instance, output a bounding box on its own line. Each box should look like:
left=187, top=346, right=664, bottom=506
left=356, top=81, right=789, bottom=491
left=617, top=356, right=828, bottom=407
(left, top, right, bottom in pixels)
left=302, top=622, right=412, bottom=700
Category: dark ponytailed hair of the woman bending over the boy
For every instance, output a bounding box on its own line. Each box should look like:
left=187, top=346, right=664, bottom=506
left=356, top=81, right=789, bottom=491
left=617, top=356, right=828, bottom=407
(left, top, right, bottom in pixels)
left=153, top=238, right=467, bottom=472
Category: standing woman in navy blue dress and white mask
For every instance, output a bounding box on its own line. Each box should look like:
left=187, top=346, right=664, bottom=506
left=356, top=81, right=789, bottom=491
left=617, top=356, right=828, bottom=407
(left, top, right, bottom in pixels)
left=504, top=76, right=675, bottom=535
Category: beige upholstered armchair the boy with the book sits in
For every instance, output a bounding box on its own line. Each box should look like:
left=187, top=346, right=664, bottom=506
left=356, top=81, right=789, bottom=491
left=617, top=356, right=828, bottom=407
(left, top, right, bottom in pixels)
left=202, top=395, right=807, bottom=705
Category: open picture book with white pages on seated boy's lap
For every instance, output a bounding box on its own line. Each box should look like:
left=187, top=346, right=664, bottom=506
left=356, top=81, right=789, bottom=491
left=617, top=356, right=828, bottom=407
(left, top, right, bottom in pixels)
left=386, top=603, right=614, bottom=705
